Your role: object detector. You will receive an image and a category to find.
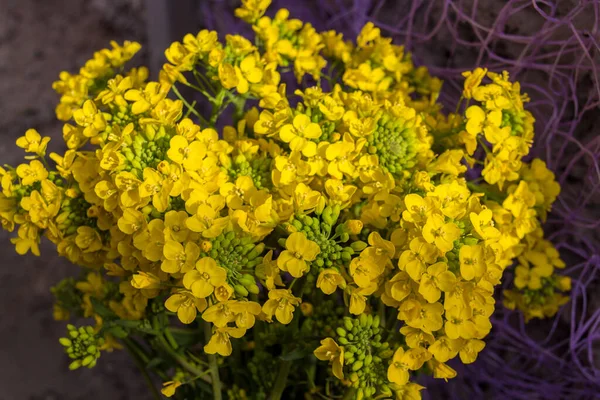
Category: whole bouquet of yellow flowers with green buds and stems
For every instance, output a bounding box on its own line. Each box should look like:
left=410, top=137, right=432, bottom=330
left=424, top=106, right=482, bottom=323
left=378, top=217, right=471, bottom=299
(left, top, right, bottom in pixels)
left=0, top=0, right=570, bottom=400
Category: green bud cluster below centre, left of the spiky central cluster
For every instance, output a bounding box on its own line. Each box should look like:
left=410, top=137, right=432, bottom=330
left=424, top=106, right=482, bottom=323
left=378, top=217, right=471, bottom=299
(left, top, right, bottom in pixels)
left=201, top=231, right=265, bottom=297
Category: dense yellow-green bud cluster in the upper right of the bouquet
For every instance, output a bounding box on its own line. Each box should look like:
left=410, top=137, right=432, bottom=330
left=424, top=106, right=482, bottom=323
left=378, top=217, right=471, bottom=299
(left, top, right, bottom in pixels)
left=367, top=113, right=417, bottom=177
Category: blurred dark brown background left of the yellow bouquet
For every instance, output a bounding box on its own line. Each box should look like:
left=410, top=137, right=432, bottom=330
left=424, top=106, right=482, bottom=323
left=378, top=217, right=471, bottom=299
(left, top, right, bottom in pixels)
left=0, top=0, right=148, bottom=400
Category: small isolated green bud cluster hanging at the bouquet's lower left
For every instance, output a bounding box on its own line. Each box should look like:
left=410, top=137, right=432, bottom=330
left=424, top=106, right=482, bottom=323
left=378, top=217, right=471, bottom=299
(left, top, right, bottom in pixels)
left=59, top=324, right=104, bottom=370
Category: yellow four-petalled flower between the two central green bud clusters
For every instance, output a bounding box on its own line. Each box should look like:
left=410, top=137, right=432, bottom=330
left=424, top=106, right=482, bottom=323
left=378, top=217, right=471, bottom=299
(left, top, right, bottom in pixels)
left=277, top=232, right=321, bottom=278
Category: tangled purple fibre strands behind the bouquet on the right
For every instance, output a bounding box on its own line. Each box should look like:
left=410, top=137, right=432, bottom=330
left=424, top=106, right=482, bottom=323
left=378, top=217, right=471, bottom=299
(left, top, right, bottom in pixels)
left=199, top=0, right=600, bottom=400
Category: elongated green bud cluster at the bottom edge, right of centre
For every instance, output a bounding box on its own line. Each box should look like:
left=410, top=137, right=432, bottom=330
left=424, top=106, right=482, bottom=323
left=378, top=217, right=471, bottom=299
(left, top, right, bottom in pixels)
left=336, top=314, right=394, bottom=399
